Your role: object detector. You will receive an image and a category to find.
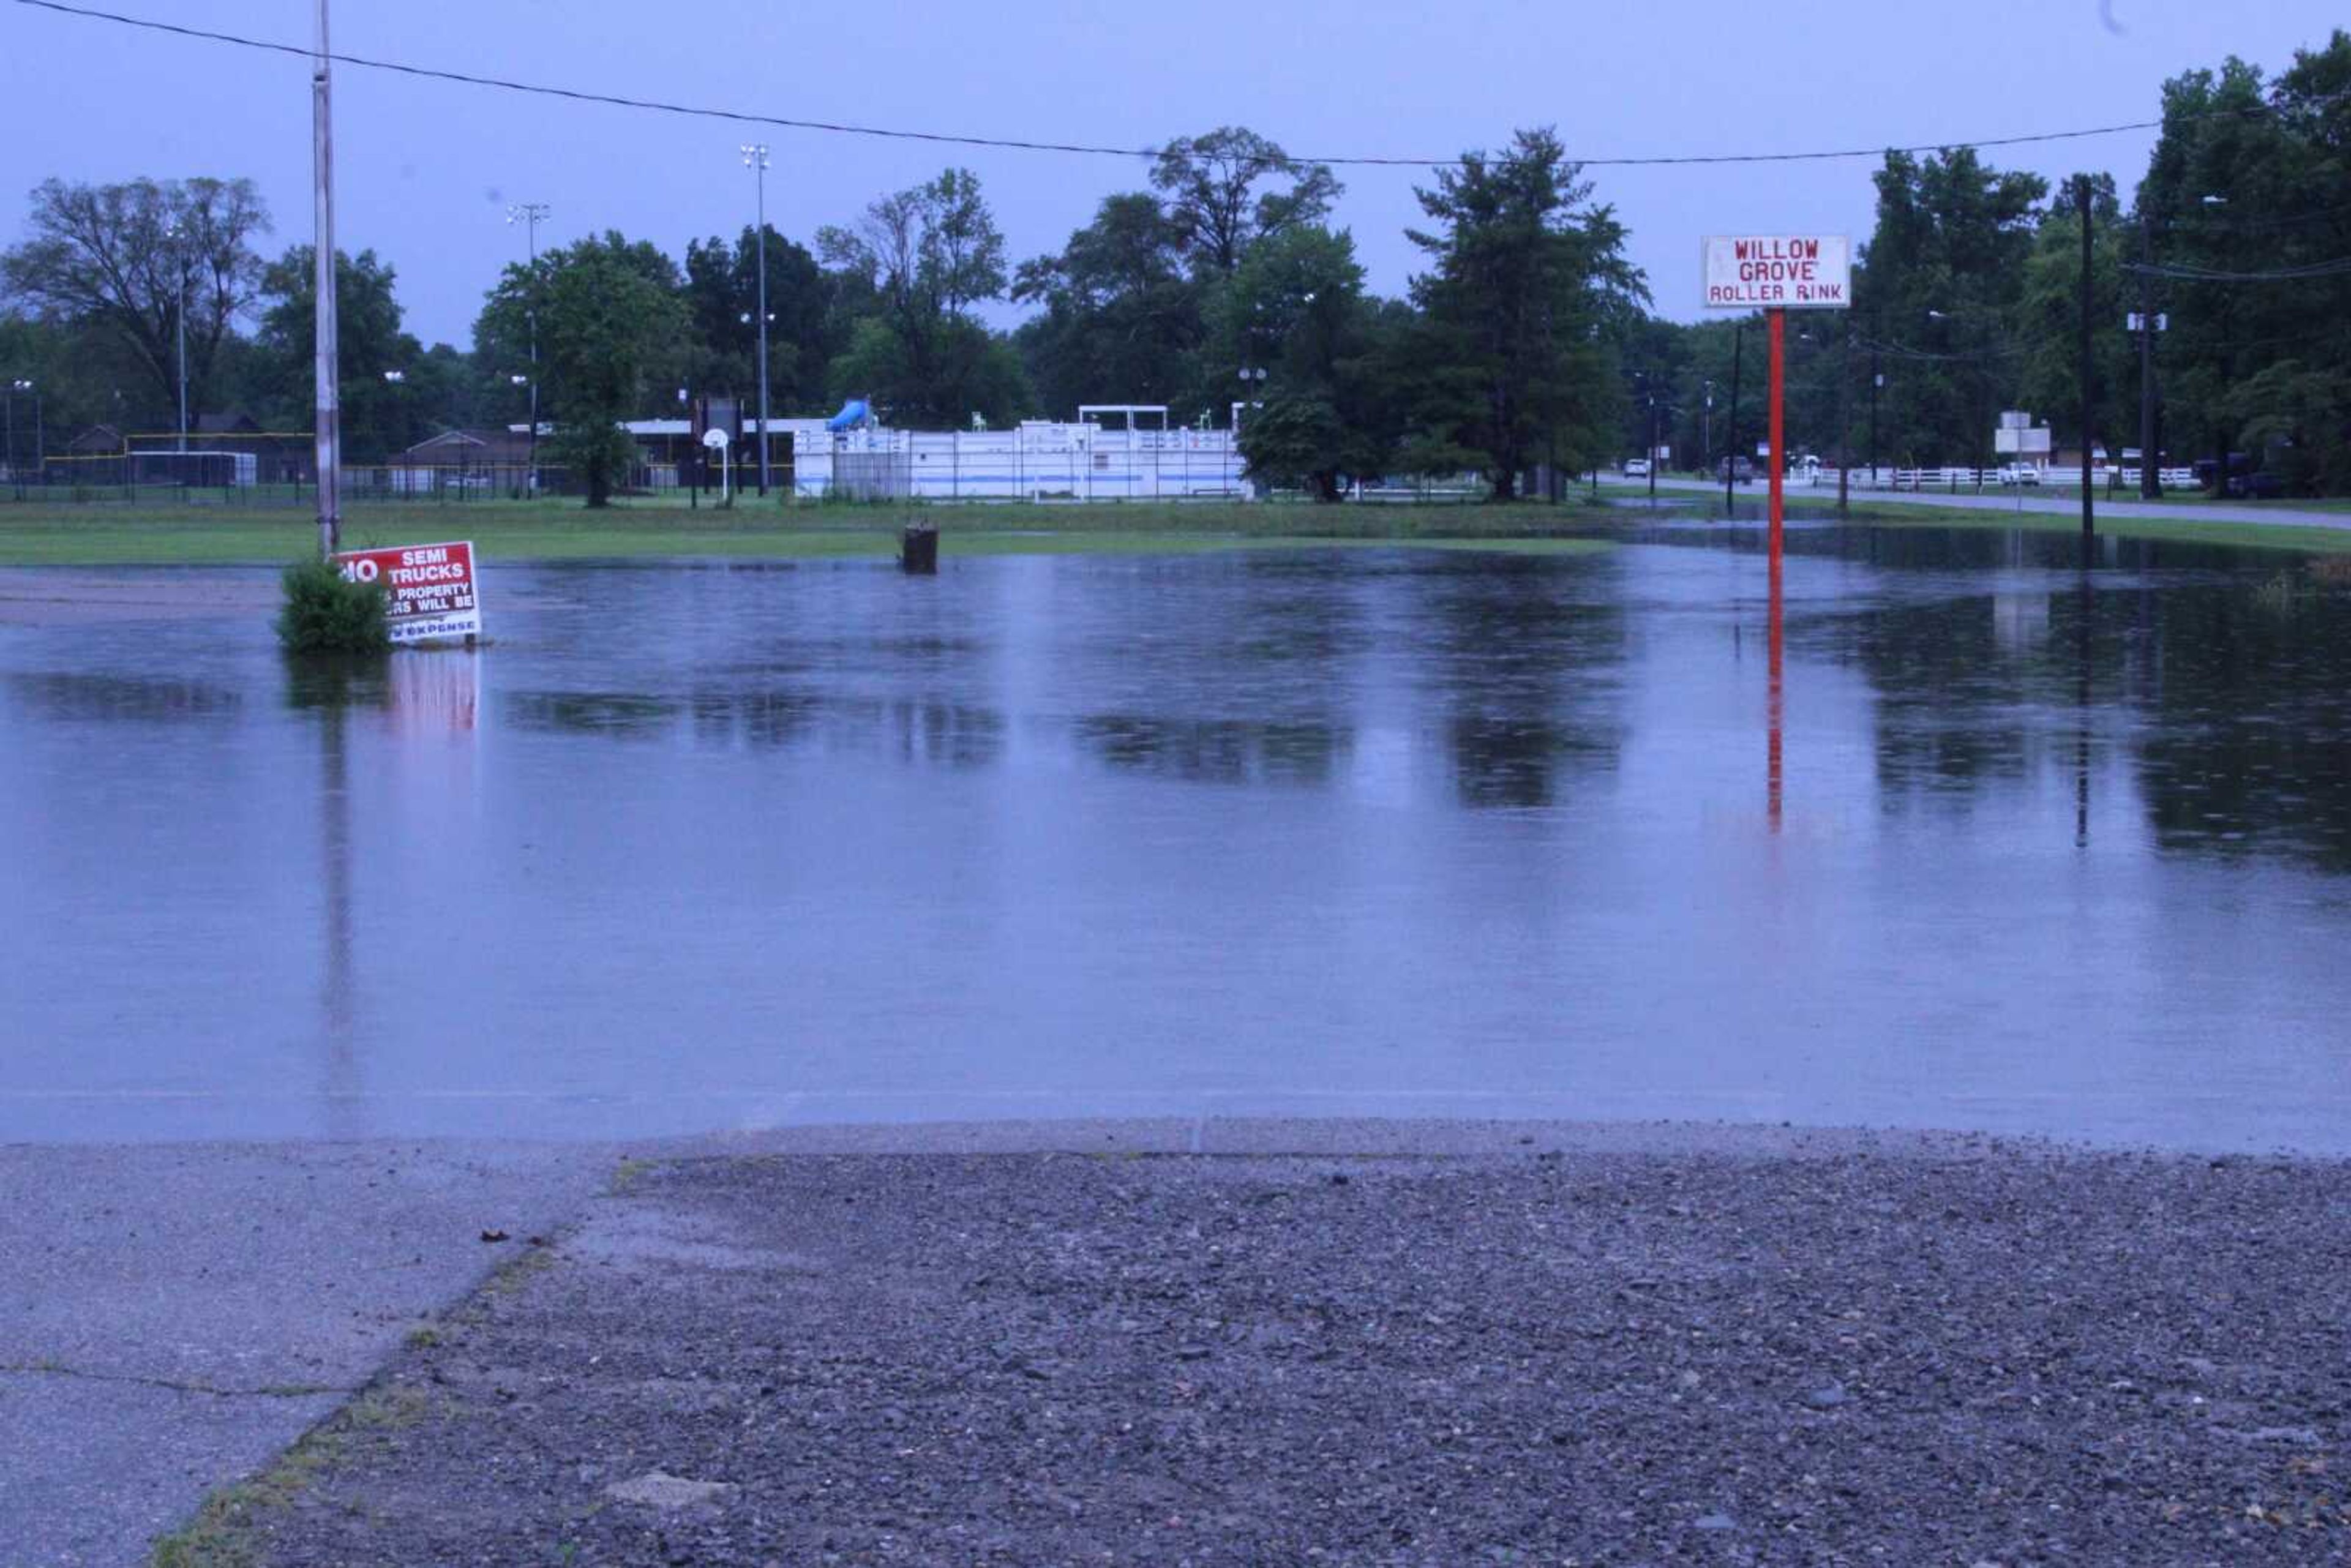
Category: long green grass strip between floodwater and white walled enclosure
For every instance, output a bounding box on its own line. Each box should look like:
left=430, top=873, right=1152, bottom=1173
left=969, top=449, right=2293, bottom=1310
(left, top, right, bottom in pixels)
left=0, top=501, right=1608, bottom=566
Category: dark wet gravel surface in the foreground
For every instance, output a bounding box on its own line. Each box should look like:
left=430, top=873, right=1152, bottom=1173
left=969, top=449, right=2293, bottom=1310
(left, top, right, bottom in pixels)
left=224, top=1142, right=2351, bottom=1568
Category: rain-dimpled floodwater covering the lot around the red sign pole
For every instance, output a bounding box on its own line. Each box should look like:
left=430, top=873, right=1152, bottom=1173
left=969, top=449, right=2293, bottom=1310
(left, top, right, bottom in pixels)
left=0, top=527, right=2351, bottom=1152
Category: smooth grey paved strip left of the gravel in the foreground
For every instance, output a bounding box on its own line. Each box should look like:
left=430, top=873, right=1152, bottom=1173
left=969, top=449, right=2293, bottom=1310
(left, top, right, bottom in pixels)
left=0, top=1142, right=613, bottom=1568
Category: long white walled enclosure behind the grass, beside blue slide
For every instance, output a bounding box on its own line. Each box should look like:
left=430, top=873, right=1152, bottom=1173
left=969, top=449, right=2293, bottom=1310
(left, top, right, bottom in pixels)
left=792, top=421, right=1251, bottom=501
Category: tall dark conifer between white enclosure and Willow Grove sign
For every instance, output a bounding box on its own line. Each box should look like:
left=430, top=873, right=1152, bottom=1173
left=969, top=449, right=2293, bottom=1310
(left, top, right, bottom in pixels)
left=1408, top=129, right=1648, bottom=501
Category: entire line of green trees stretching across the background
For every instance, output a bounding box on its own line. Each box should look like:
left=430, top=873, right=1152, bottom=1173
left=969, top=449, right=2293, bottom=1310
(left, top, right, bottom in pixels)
left=0, top=31, right=2351, bottom=498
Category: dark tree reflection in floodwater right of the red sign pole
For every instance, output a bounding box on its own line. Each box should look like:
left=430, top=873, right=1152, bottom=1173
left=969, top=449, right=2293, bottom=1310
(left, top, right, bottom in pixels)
left=1768, top=531, right=2351, bottom=872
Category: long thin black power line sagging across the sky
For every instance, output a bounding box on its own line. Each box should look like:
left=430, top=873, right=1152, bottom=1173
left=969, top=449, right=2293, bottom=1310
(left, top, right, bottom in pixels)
left=17, top=0, right=2351, bottom=169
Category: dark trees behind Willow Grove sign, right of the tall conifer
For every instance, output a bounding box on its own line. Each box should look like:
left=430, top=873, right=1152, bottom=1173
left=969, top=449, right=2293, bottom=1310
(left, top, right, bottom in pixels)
left=1620, top=31, right=2351, bottom=496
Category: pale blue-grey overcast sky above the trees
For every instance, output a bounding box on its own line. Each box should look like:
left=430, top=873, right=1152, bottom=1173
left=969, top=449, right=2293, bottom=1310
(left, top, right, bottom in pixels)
left=0, top=0, right=2344, bottom=376
